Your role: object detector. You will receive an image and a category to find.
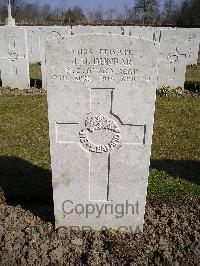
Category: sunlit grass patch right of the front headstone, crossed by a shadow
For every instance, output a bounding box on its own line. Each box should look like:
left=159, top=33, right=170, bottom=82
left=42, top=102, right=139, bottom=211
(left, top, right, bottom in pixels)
left=148, top=97, right=200, bottom=197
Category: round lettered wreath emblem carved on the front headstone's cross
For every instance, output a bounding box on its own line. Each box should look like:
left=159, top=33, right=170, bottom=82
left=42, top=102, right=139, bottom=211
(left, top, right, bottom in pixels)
left=79, top=114, right=121, bottom=153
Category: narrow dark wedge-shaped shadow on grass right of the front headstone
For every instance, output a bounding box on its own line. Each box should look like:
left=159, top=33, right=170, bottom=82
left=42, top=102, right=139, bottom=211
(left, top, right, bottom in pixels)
left=150, top=160, right=200, bottom=185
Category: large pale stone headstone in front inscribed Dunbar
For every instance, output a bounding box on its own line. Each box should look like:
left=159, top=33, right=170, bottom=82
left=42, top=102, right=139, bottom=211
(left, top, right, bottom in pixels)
left=46, top=34, right=159, bottom=232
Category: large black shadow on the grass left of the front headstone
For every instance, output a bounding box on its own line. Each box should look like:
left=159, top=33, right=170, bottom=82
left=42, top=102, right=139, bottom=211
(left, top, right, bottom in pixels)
left=0, top=157, right=54, bottom=222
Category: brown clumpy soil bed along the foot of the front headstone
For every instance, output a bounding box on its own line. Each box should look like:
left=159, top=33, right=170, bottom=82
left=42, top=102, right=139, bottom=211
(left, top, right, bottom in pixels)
left=0, top=194, right=200, bottom=266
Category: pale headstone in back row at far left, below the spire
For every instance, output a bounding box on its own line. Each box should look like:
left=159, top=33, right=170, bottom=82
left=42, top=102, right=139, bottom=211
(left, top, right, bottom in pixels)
left=0, top=26, right=30, bottom=89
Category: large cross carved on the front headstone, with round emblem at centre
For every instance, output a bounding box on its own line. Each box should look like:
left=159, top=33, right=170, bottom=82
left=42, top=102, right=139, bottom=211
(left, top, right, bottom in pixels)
left=56, top=88, right=146, bottom=201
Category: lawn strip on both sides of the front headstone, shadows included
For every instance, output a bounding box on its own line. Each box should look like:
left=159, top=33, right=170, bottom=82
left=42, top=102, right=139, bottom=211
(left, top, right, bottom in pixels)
left=0, top=92, right=200, bottom=201
